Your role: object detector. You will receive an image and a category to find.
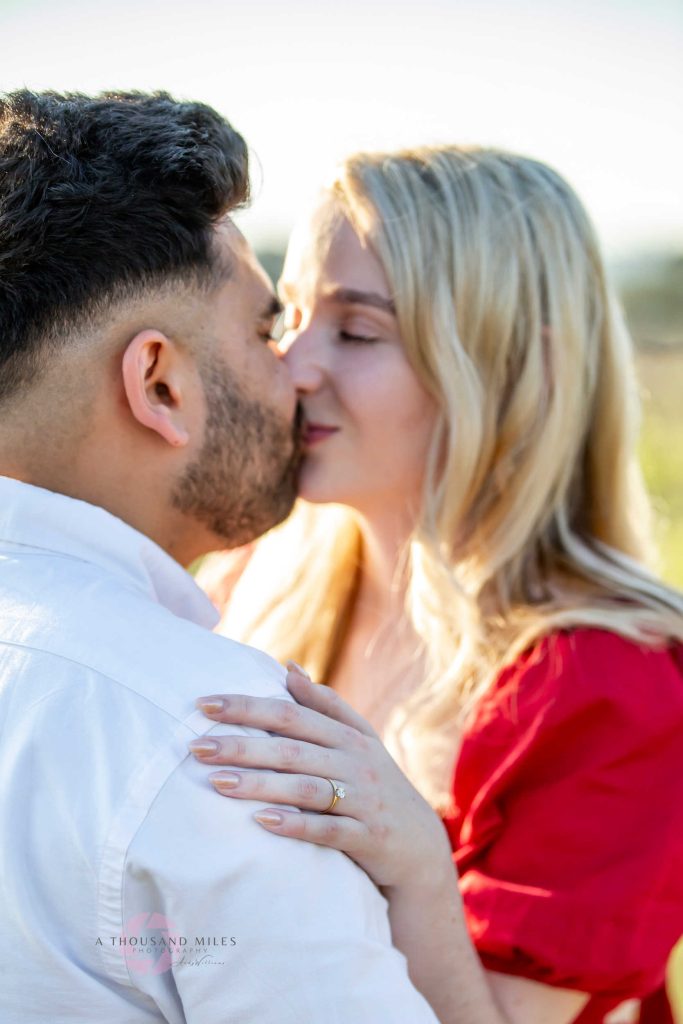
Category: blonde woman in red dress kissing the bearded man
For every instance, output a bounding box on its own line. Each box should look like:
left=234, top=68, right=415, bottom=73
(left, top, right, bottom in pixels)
left=188, top=146, right=683, bottom=1024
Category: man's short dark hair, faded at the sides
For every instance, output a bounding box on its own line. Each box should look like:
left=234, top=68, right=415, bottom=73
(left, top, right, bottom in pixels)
left=0, top=90, right=249, bottom=400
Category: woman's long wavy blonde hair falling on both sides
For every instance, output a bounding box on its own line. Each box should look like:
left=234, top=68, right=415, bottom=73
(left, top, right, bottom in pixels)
left=202, top=146, right=683, bottom=807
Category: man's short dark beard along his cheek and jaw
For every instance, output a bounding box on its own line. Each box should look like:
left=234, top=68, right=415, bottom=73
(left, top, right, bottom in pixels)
left=171, top=366, right=301, bottom=548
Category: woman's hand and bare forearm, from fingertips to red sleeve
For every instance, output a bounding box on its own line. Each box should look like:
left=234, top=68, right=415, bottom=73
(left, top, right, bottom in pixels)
left=189, top=663, right=587, bottom=1024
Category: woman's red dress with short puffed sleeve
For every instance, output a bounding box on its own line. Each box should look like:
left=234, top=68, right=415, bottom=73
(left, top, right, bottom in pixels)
left=444, top=629, right=683, bottom=1024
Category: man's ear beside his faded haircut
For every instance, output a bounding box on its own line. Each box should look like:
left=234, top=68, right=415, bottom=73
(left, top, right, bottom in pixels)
left=121, top=330, right=189, bottom=447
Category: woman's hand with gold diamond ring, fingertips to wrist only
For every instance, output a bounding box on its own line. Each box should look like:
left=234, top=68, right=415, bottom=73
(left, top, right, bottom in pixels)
left=189, top=663, right=453, bottom=887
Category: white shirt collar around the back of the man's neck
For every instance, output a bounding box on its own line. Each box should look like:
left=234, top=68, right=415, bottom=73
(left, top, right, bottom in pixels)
left=0, top=476, right=220, bottom=629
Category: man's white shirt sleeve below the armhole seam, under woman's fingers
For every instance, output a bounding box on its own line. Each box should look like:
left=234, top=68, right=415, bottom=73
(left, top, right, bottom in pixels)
left=117, top=727, right=436, bottom=1024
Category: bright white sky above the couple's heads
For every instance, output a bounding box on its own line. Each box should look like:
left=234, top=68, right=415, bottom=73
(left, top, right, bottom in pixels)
left=0, top=0, right=683, bottom=257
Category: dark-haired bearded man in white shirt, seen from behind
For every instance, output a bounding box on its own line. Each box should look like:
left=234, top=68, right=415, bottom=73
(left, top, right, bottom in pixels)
left=0, top=91, right=434, bottom=1024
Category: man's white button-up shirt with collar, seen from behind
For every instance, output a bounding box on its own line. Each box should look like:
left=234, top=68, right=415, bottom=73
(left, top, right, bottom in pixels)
left=0, top=477, right=435, bottom=1024
